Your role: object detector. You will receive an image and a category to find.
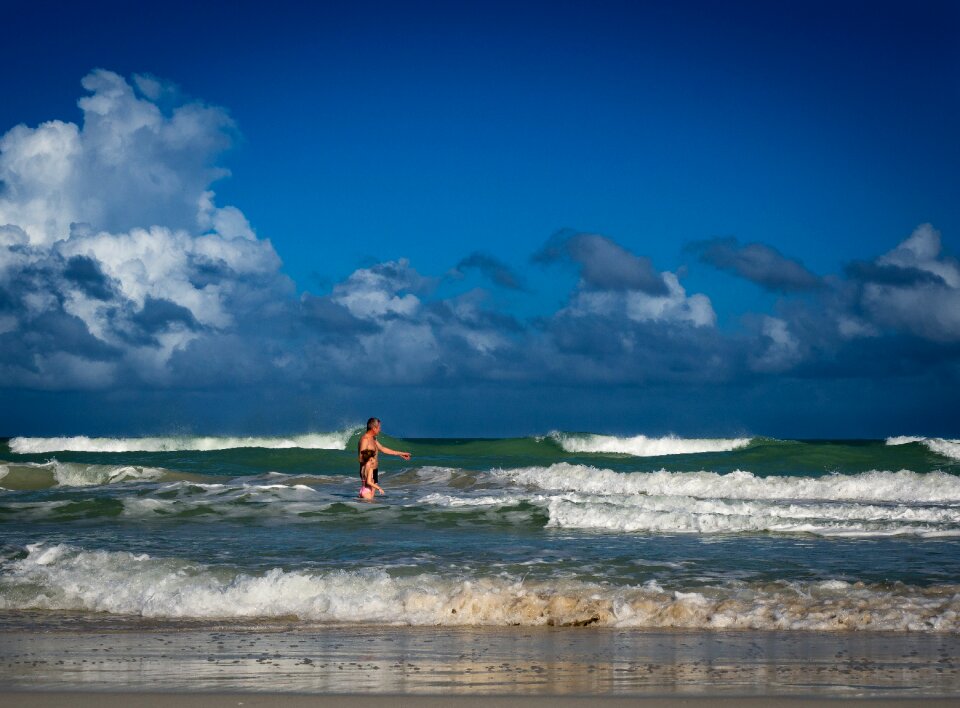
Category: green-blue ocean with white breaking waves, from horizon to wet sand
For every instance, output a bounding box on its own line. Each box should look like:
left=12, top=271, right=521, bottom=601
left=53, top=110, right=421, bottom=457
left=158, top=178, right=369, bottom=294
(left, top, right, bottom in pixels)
left=0, top=429, right=960, bottom=633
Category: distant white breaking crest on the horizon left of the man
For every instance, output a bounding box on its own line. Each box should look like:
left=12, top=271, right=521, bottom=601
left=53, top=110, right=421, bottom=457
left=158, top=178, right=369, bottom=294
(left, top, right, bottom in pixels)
left=10, top=428, right=357, bottom=455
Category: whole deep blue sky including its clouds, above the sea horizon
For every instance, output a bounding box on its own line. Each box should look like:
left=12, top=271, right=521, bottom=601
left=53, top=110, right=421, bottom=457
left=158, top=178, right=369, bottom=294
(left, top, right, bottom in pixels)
left=0, top=0, right=960, bottom=438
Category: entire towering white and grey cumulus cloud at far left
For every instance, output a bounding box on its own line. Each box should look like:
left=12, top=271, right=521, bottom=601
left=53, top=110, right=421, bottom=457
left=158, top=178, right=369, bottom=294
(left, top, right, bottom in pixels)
left=0, top=70, right=290, bottom=387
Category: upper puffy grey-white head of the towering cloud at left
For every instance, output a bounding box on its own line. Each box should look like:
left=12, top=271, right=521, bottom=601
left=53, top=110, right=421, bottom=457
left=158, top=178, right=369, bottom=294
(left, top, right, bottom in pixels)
left=0, top=70, right=234, bottom=245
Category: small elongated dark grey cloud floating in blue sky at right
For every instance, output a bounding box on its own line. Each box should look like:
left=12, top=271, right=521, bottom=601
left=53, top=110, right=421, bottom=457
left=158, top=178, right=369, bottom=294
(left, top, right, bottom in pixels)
left=687, top=237, right=820, bottom=293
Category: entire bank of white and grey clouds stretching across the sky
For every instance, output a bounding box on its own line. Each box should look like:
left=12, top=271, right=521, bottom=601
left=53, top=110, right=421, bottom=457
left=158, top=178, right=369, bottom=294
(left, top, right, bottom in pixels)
left=0, top=70, right=960, bottom=432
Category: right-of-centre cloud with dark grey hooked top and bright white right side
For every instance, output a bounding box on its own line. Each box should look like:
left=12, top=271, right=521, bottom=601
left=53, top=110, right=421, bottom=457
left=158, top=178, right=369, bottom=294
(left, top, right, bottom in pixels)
left=534, top=233, right=733, bottom=383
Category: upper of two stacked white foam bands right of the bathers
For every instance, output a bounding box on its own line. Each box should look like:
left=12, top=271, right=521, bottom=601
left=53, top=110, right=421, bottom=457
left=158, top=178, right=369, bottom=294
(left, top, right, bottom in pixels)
left=493, top=462, right=960, bottom=504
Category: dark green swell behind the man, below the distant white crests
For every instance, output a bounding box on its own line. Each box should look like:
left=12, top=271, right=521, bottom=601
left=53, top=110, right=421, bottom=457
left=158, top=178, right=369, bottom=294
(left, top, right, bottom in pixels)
left=0, top=433, right=960, bottom=488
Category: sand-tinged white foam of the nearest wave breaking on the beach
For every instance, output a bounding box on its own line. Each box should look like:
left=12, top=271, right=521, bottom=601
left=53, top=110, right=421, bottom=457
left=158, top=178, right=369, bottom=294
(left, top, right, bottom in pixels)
left=0, top=544, right=960, bottom=632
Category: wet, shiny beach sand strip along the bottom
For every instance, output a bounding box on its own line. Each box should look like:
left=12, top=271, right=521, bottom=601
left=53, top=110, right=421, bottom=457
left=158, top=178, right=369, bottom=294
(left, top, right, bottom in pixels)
left=0, top=613, right=960, bottom=708
